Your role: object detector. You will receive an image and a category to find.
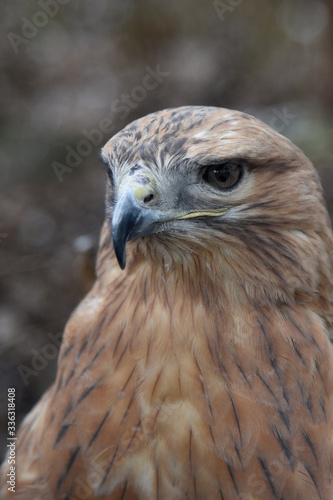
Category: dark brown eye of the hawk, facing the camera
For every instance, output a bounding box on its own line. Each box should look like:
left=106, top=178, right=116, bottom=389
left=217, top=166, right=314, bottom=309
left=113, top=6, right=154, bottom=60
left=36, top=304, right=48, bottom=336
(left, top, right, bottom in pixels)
left=203, top=161, right=244, bottom=189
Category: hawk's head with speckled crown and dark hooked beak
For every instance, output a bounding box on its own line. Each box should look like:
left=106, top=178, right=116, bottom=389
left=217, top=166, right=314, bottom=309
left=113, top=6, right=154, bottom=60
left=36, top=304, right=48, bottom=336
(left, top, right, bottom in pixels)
left=102, top=106, right=332, bottom=308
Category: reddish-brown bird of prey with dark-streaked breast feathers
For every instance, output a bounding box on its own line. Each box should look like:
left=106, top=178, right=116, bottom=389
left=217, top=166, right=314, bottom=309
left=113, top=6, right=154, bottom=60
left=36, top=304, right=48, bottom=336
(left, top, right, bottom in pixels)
left=2, top=106, right=333, bottom=500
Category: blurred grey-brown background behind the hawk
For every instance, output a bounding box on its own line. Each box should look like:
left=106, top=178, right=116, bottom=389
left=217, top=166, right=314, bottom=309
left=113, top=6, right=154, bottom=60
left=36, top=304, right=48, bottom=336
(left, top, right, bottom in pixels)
left=0, top=0, right=333, bottom=453
